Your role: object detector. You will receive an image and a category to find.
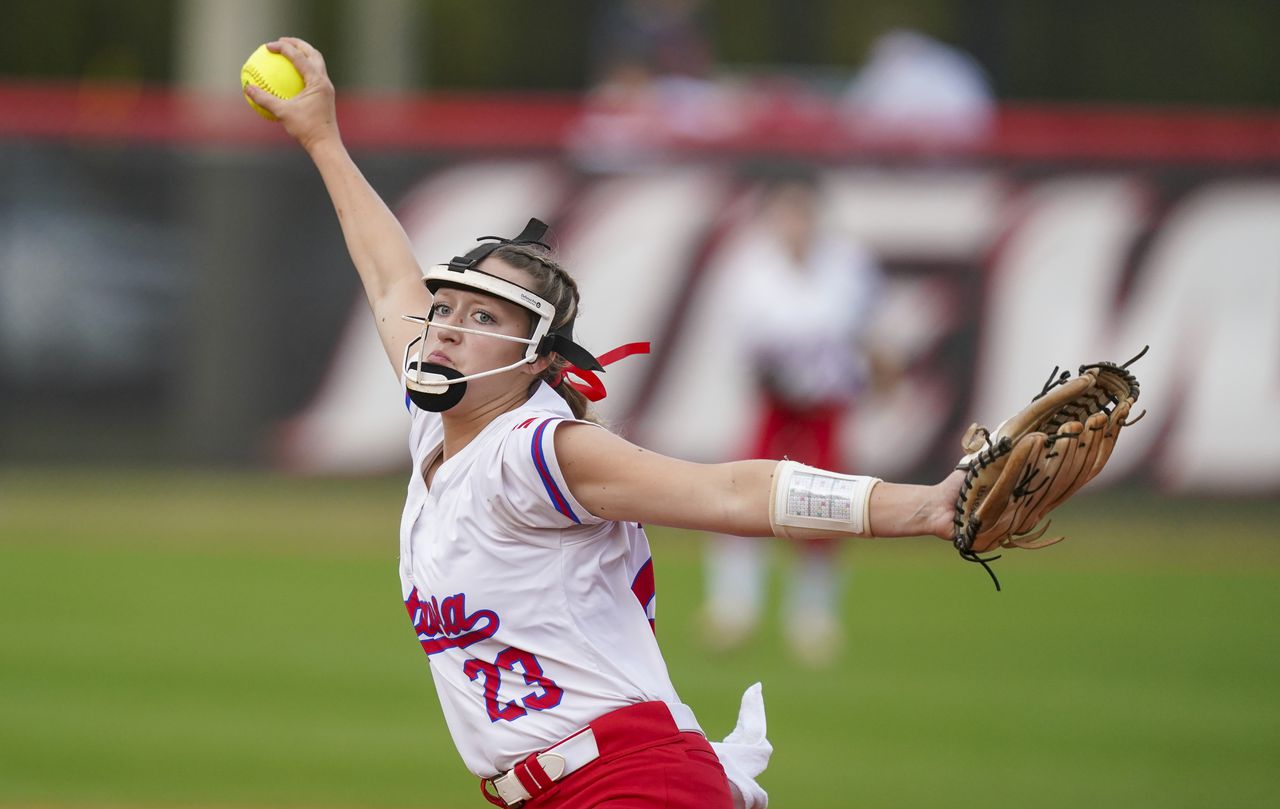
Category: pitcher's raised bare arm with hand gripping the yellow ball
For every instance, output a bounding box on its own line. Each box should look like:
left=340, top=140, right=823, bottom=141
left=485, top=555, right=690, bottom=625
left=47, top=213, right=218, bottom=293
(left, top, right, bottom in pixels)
left=244, top=37, right=430, bottom=375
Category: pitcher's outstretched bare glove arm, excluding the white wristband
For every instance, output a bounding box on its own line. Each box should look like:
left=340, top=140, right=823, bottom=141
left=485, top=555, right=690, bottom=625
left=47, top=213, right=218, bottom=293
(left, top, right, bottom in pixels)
left=556, top=424, right=964, bottom=539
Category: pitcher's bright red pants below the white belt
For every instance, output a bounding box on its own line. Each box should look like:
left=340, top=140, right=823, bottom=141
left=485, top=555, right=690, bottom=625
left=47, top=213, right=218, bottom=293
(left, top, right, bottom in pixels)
left=491, top=703, right=733, bottom=809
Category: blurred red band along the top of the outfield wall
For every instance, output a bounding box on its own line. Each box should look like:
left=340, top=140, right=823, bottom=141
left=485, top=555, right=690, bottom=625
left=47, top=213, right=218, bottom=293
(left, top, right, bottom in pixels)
left=0, top=82, right=1280, bottom=161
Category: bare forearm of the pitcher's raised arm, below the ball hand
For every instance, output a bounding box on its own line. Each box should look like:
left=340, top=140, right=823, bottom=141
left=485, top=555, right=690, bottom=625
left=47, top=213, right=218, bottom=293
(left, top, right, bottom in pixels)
left=306, top=137, right=421, bottom=311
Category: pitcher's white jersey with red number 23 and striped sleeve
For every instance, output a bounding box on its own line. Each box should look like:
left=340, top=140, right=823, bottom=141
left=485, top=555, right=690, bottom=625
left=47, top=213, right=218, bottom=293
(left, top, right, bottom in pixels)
left=399, top=384, right=678, bottom=777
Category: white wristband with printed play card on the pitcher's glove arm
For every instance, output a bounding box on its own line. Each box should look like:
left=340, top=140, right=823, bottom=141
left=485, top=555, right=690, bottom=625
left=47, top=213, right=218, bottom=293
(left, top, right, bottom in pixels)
left=769, top=461, right=881, bottom=539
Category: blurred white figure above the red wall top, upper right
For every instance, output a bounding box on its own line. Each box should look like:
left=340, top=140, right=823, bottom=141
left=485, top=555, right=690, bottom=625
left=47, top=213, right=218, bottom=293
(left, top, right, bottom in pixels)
left=844, top=28, right=995, bottom=147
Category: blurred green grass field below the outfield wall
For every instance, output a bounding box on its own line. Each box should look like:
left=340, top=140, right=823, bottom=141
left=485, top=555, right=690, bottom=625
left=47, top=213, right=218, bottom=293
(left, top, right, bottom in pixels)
left=0, top=470, right=1280, bottom=809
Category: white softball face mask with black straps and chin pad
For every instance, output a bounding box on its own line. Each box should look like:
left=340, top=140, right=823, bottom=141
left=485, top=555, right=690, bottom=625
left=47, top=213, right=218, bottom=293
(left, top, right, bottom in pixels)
left=404, top=219, right=604, bottom=412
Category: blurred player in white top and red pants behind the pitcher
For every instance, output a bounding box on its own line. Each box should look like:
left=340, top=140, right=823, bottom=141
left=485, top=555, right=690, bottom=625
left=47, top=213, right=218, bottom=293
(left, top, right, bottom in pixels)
left=704, top=169, right=883, bottom=667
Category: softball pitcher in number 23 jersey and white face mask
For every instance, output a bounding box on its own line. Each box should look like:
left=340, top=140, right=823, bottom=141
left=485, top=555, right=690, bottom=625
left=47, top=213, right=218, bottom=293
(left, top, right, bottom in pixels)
left=246, top=37, right=963, bottom=809
